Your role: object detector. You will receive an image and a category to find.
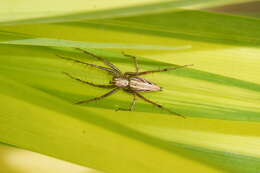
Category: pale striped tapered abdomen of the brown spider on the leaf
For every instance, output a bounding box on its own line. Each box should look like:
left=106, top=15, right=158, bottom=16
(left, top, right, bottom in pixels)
left=129, top=77, right=162, bottom=92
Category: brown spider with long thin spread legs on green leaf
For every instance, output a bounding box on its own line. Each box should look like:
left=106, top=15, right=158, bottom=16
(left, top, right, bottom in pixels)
left=57, top=48, right=192, bottom=118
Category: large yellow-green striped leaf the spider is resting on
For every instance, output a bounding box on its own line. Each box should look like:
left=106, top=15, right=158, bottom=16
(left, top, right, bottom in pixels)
left=0, top=2, right=260, bottom=173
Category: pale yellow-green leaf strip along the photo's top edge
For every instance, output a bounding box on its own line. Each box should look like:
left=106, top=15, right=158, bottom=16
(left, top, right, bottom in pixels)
left=0, top=0, right=251, bottom=25
